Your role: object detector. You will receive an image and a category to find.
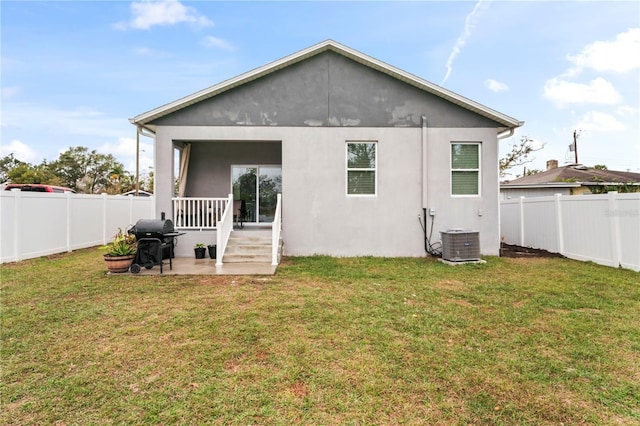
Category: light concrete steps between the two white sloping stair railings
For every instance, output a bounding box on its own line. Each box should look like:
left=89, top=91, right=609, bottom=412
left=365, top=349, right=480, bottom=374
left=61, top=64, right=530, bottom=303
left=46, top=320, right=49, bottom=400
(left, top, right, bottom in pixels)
left=222, top=229, right=282, bottom=263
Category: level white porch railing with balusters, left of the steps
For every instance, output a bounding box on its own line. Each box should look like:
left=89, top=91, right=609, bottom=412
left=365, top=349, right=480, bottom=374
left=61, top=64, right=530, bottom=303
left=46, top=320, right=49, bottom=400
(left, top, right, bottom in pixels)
left=172, top=197, right=233, bottom=229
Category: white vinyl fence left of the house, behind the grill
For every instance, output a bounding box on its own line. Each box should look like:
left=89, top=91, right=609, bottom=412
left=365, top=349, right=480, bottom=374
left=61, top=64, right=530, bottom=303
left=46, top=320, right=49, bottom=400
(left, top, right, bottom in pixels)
left=0, top=191, right=155, bottom=263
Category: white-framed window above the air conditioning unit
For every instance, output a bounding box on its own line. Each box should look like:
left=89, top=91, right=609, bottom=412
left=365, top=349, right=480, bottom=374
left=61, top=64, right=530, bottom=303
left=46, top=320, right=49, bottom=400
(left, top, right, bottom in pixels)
left=451, top=143, right=480, bottom=195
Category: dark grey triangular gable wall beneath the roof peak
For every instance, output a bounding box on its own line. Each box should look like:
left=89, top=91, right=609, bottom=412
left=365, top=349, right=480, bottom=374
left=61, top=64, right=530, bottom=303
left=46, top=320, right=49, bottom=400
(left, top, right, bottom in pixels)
left=151, top=52, right=500, bottom=128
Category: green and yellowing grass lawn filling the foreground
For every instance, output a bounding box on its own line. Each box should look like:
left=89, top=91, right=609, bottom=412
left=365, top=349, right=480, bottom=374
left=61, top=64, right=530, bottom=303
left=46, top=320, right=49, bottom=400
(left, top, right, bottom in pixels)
left=0, top=249, right=640, bottom=425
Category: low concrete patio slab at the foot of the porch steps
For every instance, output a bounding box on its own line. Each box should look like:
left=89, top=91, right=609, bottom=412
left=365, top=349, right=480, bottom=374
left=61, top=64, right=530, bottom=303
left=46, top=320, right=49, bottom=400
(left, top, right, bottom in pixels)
left=118, top=257, right=277, bottom=276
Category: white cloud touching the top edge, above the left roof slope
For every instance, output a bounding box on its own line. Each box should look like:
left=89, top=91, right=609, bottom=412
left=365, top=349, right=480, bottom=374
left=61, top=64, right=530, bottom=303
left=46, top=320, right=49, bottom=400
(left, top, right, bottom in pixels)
left=114, top=0, right=213, bottom=30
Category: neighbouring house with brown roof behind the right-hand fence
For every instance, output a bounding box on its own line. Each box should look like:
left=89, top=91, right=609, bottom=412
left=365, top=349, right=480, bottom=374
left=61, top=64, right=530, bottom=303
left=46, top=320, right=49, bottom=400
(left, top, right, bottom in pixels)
left=500, top=160, right=640, bottom=200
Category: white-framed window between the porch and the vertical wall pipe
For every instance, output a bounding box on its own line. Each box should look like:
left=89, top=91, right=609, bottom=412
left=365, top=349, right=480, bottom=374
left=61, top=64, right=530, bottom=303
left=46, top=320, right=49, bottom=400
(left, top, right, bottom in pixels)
left=347, top=142, right=377, bottom=195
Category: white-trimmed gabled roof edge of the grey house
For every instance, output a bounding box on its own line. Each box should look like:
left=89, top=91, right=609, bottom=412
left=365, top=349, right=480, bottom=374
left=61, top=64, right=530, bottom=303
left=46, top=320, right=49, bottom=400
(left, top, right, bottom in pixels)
left=129, top=40, right=524, bottom=129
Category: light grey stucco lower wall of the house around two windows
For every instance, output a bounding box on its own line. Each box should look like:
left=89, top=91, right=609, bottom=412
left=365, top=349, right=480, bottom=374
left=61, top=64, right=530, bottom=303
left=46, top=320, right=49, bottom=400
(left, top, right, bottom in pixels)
left=155, top=126, right=499, bottom=256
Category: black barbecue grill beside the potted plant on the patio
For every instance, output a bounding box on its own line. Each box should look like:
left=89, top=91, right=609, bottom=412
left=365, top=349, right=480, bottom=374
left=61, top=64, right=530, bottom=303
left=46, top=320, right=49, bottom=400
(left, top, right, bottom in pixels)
left=129, top=219, right=184, bottom=274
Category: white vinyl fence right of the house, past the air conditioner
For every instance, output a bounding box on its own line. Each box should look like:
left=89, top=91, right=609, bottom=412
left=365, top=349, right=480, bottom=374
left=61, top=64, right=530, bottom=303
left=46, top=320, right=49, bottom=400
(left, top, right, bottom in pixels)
left=500, top=192, right=640, bottom=271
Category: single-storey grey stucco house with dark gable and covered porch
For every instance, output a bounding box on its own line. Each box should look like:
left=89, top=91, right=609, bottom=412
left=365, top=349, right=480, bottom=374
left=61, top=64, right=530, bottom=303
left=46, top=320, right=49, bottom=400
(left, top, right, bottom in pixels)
left=130, top=40, right=523, bottom=257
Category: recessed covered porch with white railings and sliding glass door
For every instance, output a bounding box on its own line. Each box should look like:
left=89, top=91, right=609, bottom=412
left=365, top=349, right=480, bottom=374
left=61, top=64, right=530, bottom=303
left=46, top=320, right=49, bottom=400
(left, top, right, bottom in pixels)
left=156, top=138, right=282, bottom=267
